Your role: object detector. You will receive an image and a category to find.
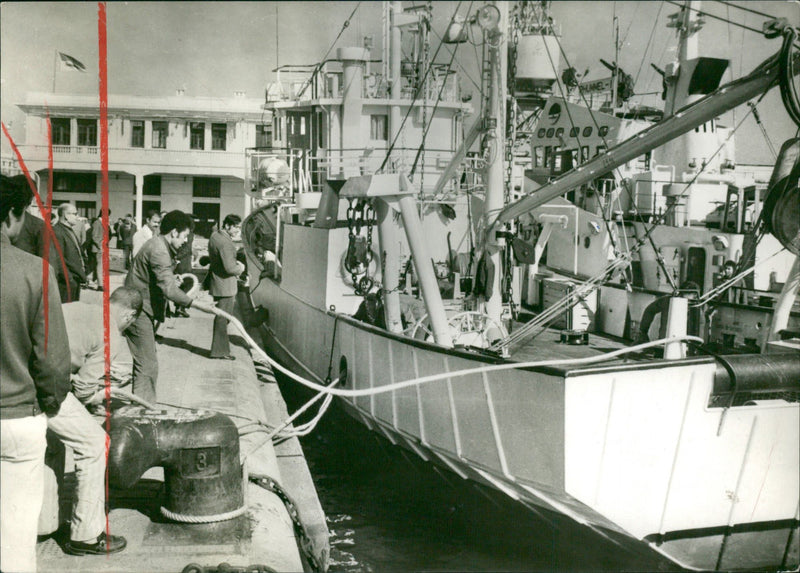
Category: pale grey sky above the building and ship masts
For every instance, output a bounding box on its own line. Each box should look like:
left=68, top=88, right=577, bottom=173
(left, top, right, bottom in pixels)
left=0, top=0, right=800, bottom=163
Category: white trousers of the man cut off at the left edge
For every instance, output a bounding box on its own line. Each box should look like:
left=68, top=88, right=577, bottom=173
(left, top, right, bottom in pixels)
left=0, top=414, right=47, bottom=573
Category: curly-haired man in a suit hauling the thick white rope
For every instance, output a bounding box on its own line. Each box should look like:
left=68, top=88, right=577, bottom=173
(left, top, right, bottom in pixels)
left=125, top=211, right=215, bottom=402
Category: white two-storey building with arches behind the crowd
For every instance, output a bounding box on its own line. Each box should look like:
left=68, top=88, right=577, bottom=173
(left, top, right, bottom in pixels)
left=19, top=90, right=271, bottom=234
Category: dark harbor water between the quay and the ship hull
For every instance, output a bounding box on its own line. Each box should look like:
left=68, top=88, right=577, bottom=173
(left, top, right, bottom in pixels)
left=280, top=380, right=675, bottom=573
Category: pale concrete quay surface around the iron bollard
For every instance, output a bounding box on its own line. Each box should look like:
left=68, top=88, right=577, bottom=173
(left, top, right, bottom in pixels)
left=37, top=271, right=329, bottom=573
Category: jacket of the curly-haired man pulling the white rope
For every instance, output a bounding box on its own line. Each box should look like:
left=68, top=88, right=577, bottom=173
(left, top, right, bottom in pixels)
left=125, top=235, right=192, bottom=321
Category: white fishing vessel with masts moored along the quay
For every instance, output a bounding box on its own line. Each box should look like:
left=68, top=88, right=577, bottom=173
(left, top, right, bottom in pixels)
left=243, top=2, right=800, bottom=570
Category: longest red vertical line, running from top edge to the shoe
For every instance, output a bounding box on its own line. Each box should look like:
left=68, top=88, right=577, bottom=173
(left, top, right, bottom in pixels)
left=97, top=2, right=111, bottom=548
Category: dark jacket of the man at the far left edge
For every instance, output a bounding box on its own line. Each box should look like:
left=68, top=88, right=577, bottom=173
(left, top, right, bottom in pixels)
left=0, top=234, right=70, bottom=419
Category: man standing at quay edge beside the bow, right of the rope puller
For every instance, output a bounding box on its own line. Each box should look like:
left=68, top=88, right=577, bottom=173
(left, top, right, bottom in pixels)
left=208, top=215, right=244, bottom=360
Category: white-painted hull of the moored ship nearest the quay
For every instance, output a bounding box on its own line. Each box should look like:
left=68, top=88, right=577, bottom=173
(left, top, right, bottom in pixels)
left=251, top=254, right=800, bottom=570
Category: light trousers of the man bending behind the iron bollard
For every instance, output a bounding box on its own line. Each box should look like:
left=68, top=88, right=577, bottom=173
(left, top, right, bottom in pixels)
left=47, top=392, right=106, bottom=541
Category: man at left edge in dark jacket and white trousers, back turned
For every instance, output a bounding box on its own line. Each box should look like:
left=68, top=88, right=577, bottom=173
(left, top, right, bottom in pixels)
left=0, top=175, right=70, bottom=571
